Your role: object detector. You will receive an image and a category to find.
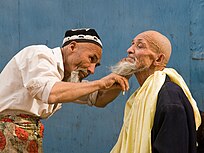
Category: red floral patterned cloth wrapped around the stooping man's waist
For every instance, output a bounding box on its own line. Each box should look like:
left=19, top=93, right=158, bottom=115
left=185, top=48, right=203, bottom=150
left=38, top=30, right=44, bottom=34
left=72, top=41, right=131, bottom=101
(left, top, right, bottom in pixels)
left=0, top=114, right=44, bottom=153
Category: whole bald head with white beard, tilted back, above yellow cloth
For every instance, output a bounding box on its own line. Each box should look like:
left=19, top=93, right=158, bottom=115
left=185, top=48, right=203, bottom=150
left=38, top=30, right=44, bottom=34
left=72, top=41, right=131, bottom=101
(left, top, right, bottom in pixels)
left=111, top=30, right=171, bottom=81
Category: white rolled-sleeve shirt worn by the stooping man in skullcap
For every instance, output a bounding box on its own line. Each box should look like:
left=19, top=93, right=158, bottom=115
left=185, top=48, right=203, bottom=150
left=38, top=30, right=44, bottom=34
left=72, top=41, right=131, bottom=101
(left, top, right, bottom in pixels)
left=0, top=45, right=96, bottom=118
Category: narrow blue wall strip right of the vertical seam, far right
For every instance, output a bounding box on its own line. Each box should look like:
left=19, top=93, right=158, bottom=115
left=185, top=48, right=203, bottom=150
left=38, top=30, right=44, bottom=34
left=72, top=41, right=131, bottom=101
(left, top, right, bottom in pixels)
left=189, top=0, right=204, bottom=110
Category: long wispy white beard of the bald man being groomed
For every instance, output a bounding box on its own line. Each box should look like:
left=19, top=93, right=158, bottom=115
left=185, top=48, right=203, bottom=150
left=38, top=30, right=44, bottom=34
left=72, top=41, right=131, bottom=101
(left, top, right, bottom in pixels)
left=110, top=62, right=147, bottom=77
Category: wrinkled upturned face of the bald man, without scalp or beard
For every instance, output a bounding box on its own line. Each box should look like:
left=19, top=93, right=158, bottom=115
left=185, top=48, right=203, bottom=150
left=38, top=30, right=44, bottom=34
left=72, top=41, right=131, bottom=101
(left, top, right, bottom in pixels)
left=127, top=34, right=156, bottom=72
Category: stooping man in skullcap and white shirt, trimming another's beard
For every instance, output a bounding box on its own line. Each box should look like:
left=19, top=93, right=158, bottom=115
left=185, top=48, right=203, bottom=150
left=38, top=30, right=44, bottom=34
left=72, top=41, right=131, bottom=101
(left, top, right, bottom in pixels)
left=0, top=29, right=128, bottom=153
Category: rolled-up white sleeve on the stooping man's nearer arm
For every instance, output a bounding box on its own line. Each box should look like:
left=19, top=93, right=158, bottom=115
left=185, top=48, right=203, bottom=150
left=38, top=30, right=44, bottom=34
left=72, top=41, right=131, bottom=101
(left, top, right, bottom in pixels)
left=16, top=48, right=61, bottom=103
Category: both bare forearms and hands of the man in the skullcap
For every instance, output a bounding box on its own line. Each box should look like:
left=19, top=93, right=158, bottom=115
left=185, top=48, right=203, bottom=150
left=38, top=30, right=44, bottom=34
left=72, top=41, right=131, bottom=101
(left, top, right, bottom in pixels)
left=48, top=73, right=129, bottom=107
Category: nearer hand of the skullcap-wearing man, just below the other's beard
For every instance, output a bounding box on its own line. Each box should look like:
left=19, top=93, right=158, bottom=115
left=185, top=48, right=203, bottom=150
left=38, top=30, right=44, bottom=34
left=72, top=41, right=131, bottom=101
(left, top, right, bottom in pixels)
left=100, top=73, right=129, bottom=91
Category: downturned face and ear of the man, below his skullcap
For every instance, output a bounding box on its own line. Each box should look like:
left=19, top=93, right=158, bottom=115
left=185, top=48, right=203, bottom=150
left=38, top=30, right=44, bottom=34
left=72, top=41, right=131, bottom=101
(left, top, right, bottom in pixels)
left=65, top=42, right=102, bottom=80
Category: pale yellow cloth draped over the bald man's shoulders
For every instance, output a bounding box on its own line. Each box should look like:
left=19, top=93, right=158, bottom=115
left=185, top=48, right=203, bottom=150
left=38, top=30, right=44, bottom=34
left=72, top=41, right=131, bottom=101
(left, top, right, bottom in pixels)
left=111, top=68, right=201, bottom=153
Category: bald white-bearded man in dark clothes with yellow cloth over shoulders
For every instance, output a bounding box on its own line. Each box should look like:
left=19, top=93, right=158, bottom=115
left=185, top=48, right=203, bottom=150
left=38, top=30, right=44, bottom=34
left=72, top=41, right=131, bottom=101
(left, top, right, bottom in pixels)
left=111, top=30, right=201, bottom=153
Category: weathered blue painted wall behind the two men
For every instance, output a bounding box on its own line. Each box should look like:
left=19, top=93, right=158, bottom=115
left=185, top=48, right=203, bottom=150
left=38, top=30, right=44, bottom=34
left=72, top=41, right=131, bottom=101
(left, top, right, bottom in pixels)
left=0, top=0, right=204, bottom=153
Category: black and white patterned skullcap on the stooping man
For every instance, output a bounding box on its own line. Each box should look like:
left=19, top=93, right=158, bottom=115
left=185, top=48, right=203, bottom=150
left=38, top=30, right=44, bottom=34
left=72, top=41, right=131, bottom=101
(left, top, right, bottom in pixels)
left=62, top=28, right=103, bottom=48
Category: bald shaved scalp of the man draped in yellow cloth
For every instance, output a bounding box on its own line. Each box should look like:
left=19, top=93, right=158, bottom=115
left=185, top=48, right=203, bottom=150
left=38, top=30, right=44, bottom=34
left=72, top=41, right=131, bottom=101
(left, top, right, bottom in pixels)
left=137, top=30, right=171, bottom=64
